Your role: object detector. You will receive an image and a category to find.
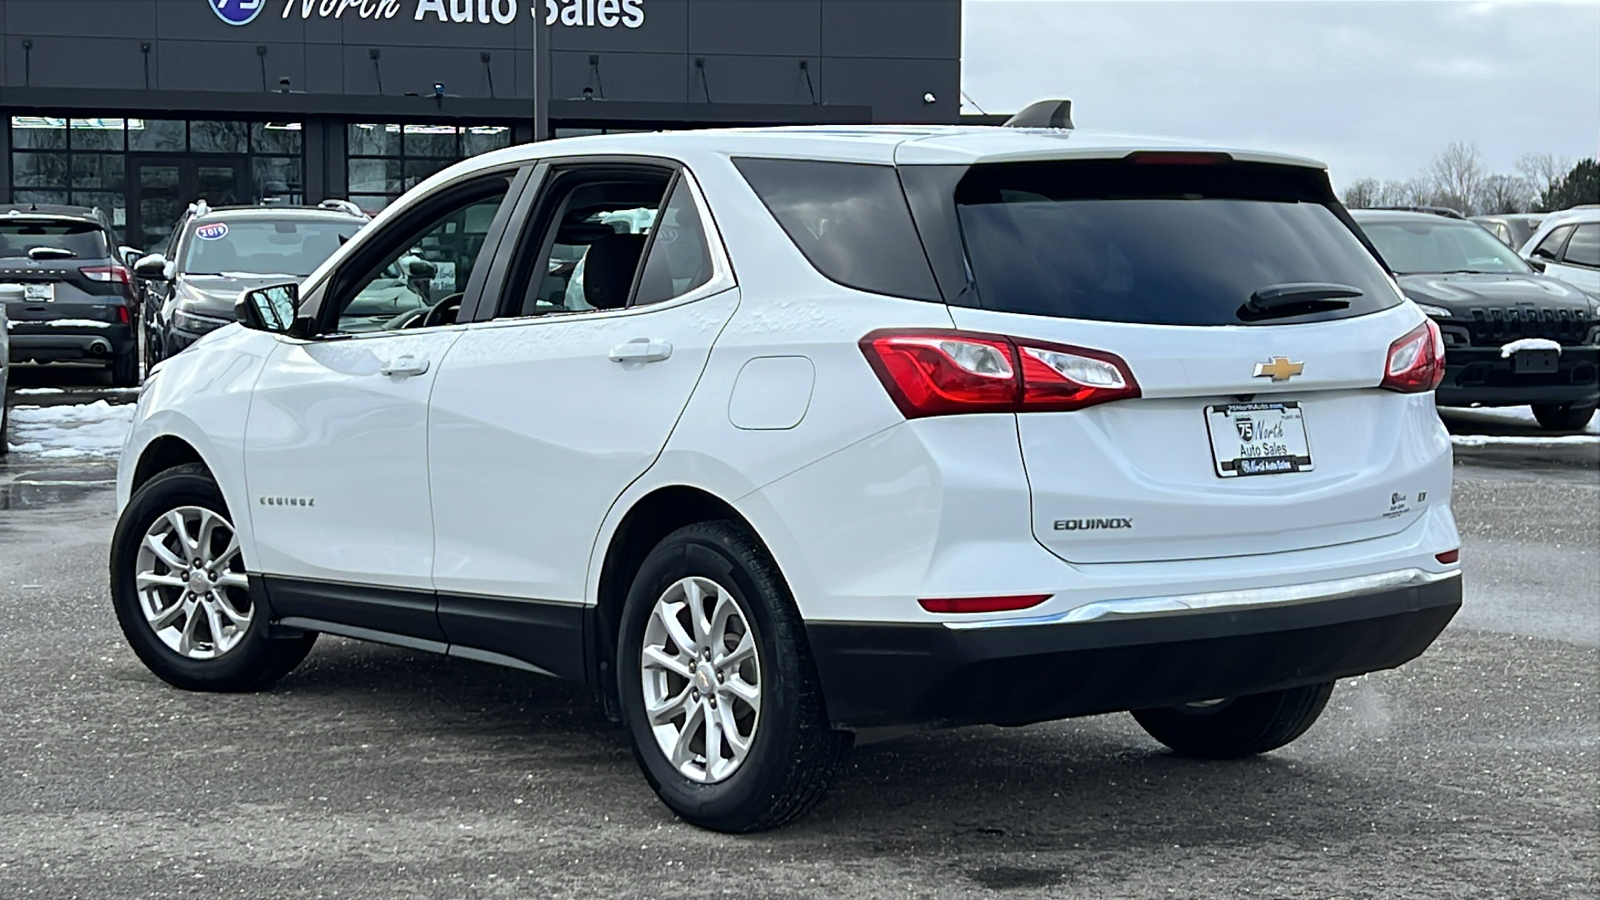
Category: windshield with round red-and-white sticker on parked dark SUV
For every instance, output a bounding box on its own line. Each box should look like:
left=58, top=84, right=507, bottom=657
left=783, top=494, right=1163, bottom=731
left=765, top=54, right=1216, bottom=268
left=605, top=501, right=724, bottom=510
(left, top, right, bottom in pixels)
left=182, top=218, right=362, bottom=279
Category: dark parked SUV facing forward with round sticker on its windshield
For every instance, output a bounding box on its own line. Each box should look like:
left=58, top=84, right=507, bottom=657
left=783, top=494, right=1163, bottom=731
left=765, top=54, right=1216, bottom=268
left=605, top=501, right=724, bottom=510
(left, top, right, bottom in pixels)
left=134, top=202, right=368, bottom=365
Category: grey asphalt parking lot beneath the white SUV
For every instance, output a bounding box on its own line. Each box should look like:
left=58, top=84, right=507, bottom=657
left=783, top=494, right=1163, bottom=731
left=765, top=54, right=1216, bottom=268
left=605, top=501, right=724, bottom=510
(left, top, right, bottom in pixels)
left=0, top=366, right=1600, bottom=900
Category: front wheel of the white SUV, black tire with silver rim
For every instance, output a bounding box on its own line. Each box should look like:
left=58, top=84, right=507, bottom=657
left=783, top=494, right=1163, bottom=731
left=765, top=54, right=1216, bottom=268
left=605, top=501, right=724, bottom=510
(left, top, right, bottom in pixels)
left=110, top=464, right=317, bottom=692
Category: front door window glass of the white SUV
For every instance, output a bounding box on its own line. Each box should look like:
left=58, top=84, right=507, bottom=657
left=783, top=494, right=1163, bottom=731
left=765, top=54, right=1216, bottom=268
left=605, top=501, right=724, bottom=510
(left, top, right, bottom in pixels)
left=336, top=176, right=510, bottom=333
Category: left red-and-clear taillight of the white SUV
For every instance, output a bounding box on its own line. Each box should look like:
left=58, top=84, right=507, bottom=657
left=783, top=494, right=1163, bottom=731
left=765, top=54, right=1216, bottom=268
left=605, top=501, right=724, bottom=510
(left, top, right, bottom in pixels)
left=861, top=330, right=1139, bottom=418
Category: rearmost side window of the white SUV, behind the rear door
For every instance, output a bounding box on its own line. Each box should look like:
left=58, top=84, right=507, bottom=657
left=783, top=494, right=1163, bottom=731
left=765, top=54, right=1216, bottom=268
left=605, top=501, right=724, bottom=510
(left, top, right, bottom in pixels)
left=733, top=159, right=939, bottom=299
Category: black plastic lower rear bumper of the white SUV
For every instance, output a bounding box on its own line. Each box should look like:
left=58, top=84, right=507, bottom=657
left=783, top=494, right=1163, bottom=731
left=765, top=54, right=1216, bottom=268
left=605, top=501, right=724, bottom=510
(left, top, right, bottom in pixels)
left=806, top=573, right=1461, bottom=729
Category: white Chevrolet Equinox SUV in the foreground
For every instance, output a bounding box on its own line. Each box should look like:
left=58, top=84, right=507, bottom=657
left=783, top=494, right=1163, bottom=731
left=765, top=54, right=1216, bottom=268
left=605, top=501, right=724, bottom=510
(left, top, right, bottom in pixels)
left=110, top=127, right=1461, bottom=831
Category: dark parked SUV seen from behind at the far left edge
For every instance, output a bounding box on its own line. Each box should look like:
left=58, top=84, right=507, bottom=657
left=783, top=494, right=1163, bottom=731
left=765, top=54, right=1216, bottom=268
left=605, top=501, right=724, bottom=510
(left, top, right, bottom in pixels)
left=0, top=205, right=139, bottom=388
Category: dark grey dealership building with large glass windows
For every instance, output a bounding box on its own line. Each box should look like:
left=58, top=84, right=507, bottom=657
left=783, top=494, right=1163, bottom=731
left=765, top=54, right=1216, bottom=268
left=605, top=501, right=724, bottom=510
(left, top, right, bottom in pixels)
left=0, top=0, right=962, bottom=247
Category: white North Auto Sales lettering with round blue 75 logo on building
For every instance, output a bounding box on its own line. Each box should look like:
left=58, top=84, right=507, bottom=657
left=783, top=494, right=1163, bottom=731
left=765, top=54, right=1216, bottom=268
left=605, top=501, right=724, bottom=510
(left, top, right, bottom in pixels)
left=252, top=0, right=645, bottom=29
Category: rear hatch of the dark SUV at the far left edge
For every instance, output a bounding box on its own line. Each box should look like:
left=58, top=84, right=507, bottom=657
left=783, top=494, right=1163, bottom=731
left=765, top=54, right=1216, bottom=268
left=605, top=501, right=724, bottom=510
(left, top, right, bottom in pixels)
left=0, top=215, right=128, bottom=328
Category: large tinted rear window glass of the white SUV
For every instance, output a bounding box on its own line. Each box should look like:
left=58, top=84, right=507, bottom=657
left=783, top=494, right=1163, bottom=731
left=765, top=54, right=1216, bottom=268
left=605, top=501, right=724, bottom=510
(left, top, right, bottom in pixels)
left=955, top=160, right=1401, bottom=325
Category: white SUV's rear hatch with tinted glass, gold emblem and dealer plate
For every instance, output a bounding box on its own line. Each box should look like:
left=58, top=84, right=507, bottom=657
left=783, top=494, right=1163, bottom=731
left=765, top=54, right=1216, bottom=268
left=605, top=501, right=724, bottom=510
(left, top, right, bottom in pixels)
left=950, top=154, right=1448, bottom=562
